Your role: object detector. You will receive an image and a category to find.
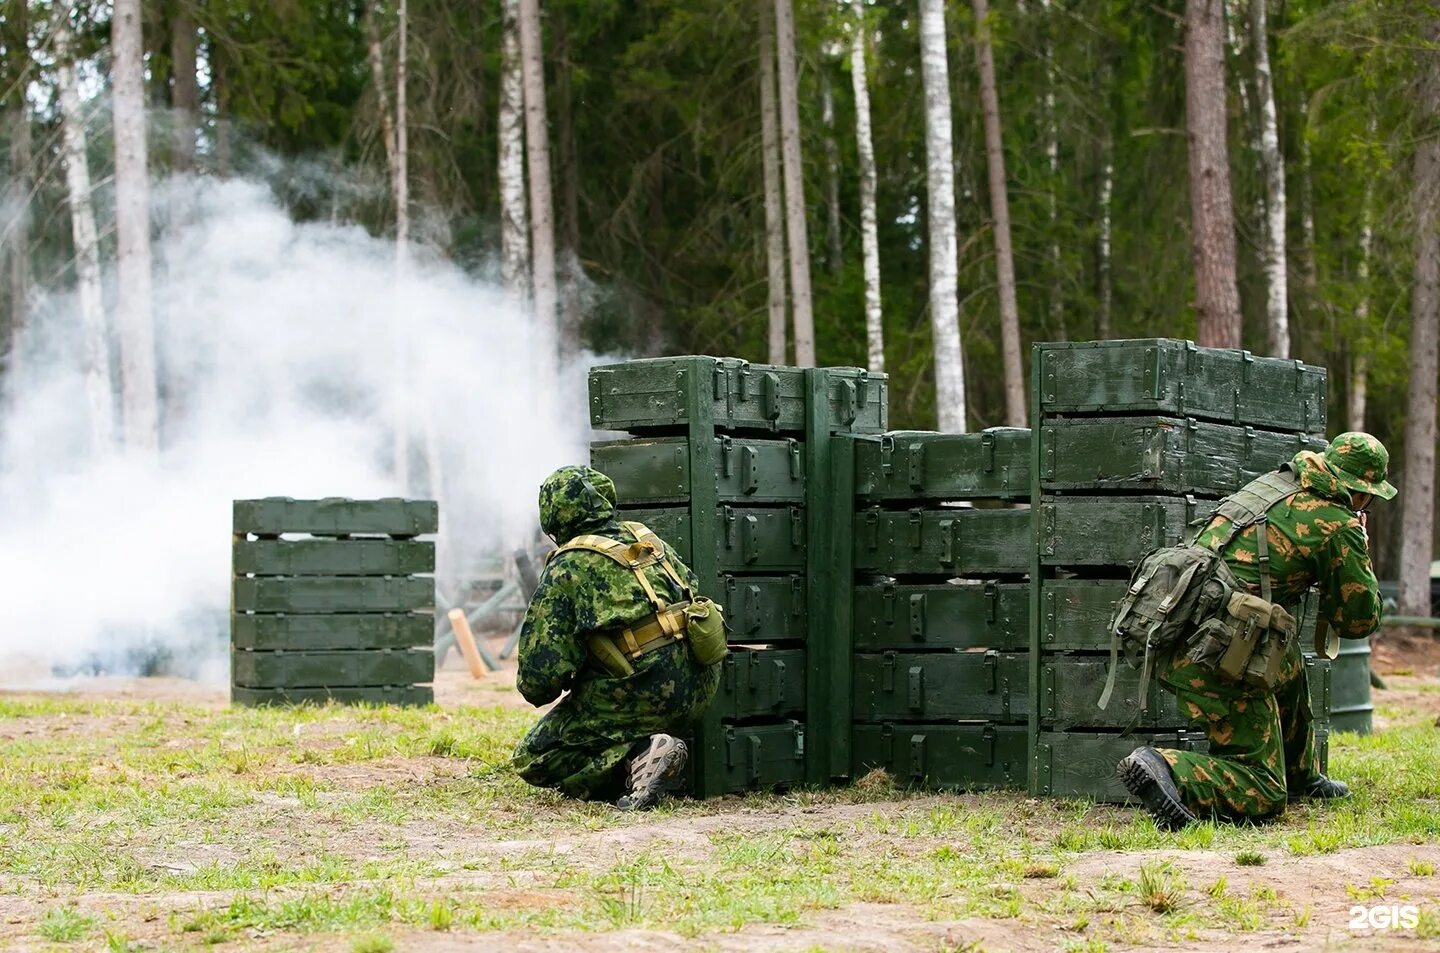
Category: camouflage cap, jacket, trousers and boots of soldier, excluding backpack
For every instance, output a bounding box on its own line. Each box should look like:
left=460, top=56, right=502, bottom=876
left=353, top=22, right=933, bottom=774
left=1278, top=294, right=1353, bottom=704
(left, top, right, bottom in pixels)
left=1119, top=433, right=1395, bottom=829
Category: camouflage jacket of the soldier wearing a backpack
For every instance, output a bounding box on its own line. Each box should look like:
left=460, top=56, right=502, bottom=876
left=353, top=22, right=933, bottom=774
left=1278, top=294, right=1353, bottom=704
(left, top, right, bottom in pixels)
left=1197, top=451, right=1380, bottom=639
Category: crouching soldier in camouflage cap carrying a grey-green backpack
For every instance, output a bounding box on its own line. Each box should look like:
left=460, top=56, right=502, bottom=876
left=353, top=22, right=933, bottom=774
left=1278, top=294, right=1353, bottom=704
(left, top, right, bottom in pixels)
left=1106, top=433, right=1395, bottom=829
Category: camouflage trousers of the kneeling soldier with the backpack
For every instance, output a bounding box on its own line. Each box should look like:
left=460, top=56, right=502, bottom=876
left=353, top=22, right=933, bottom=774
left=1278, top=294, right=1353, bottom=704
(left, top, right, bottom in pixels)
left=1161, top=648, right=1319, bottom=821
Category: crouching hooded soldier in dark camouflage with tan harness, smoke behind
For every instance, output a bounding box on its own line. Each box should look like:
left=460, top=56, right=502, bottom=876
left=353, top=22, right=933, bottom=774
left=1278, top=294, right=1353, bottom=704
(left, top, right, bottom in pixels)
left=514, top=466, right=726, bottom=810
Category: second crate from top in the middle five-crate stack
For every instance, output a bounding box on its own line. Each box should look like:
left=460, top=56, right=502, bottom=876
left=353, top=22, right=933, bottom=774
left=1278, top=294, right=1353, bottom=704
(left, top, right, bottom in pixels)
left=854, top=507, right=1031, bottom=576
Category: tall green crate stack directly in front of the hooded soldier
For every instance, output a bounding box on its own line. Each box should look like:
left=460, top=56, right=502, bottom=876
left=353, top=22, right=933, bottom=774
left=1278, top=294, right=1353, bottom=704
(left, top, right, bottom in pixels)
left=590, top=357, right=887, bottom=796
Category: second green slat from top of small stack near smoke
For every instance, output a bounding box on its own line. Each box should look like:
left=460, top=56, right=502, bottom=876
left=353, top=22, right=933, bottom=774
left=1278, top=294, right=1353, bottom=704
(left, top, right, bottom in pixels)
left=232, top=540, right=435, bottom=576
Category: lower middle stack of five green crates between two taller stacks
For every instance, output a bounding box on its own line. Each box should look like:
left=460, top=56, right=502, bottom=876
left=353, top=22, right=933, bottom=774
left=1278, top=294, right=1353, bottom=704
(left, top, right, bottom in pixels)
left=851, top=429, right=1034, bottom=787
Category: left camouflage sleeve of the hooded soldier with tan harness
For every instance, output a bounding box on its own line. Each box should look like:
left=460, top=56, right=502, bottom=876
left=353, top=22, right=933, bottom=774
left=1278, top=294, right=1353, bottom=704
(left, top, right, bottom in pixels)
left=516, top=560, right=585, bottom=705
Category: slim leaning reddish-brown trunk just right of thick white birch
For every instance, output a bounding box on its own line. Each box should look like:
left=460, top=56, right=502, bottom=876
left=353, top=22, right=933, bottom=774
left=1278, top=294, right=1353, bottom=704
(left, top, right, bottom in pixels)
left=972, top=0, right=1030, bottom=428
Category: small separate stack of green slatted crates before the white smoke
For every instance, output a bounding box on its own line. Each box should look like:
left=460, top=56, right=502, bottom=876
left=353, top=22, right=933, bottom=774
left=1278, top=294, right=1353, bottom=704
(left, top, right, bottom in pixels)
left=230, top=498, right=439, bottom=705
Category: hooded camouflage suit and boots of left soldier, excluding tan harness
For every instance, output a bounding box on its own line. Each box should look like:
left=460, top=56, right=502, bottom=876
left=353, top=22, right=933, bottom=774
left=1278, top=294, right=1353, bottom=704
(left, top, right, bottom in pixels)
left=514, top=466, right=720, bottom=809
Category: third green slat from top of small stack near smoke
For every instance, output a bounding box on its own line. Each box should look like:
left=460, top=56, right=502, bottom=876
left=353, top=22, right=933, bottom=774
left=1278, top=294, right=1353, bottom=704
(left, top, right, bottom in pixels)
left=232, top=576, right=435, bottom=613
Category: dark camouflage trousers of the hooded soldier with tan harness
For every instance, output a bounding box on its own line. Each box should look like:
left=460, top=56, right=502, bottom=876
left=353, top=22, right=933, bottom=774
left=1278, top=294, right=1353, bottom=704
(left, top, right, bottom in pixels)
left=511, top=643, right=720, bottom=800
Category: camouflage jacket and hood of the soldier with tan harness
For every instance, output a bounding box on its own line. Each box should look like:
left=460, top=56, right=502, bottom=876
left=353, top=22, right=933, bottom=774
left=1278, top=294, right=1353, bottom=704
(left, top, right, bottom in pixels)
left=516, top=466, right=700, bottom=705
